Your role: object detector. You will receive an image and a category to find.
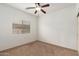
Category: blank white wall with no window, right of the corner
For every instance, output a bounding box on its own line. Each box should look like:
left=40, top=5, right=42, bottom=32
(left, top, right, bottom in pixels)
left=39, top=6, right=77, bottom=50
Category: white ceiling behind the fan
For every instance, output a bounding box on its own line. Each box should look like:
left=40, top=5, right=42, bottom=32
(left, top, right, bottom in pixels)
left=8, top=3, right=75, bottom=16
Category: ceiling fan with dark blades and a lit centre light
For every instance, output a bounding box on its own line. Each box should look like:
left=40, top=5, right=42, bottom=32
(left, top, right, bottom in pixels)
left=26, top=3, right=50, bottom=14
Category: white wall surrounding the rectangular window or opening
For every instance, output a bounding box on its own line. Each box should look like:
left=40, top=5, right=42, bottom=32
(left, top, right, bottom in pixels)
left=0, top=4, right=37, bottom=51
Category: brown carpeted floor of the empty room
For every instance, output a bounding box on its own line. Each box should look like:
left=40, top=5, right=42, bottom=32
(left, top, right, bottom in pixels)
left=2, top=41, right=78, bottom=56
